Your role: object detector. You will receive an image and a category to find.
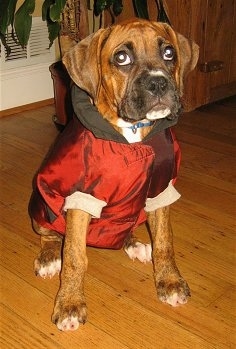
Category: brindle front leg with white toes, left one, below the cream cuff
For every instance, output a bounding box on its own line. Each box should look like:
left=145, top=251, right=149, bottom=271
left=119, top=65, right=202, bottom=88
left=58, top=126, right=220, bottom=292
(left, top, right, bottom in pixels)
left=52, top=209, right=90, bottom=331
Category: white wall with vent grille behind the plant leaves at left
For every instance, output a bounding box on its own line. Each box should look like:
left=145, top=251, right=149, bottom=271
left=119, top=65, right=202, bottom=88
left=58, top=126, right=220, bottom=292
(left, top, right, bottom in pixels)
left=0, top=17, right=55, bottom=110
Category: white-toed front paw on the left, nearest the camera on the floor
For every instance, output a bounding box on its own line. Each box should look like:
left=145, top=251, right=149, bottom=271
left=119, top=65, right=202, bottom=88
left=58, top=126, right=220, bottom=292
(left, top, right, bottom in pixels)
left=52, top=302, right=87, bottom=331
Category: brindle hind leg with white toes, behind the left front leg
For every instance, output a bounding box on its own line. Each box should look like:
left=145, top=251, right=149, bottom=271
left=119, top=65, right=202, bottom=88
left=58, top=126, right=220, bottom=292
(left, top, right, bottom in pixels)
left=33, top=221, right=62, bottom=279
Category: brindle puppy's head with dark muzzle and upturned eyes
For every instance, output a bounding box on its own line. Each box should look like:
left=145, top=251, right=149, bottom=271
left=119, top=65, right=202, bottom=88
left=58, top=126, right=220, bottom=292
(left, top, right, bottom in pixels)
left=63, top=19, right=198, bottom=125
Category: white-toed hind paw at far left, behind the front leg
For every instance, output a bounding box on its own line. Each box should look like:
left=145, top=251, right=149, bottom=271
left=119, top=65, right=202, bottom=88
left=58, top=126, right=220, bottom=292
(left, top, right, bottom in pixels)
left=34, top=258, right=61, bottom=279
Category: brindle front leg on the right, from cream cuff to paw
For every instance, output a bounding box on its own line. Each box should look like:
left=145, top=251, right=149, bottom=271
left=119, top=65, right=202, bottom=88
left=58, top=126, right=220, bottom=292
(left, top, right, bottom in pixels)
left=148, top=206, right=190, bottom=306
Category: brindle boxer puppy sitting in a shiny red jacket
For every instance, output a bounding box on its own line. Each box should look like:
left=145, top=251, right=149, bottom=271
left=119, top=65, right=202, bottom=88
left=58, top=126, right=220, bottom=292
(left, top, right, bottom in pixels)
left=30, top=19, right=199, bottom=331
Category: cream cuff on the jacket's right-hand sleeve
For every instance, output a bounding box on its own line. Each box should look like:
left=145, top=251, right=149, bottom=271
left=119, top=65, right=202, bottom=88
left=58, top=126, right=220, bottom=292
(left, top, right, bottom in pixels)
left=144, top=181, right=181, bottom=212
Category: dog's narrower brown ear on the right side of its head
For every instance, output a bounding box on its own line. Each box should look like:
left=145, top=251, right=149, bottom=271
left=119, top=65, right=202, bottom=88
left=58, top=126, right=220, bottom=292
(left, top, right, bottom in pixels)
left=176, top=33, right=199, bottom=95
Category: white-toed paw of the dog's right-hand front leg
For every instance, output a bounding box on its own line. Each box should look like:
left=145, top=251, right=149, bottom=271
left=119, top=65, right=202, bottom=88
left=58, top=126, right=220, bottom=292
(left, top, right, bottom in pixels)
left=156, top=277, right=191, bottom=307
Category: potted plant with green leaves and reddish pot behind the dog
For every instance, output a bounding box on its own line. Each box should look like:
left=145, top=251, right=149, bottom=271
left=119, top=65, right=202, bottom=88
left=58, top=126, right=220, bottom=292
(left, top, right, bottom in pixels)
left=0, top=0, right=169, bottom=126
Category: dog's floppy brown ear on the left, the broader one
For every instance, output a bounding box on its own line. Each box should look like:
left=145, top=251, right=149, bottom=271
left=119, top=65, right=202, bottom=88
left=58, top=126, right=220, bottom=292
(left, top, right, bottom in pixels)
left=62, top=29, right=110, bottom=99
